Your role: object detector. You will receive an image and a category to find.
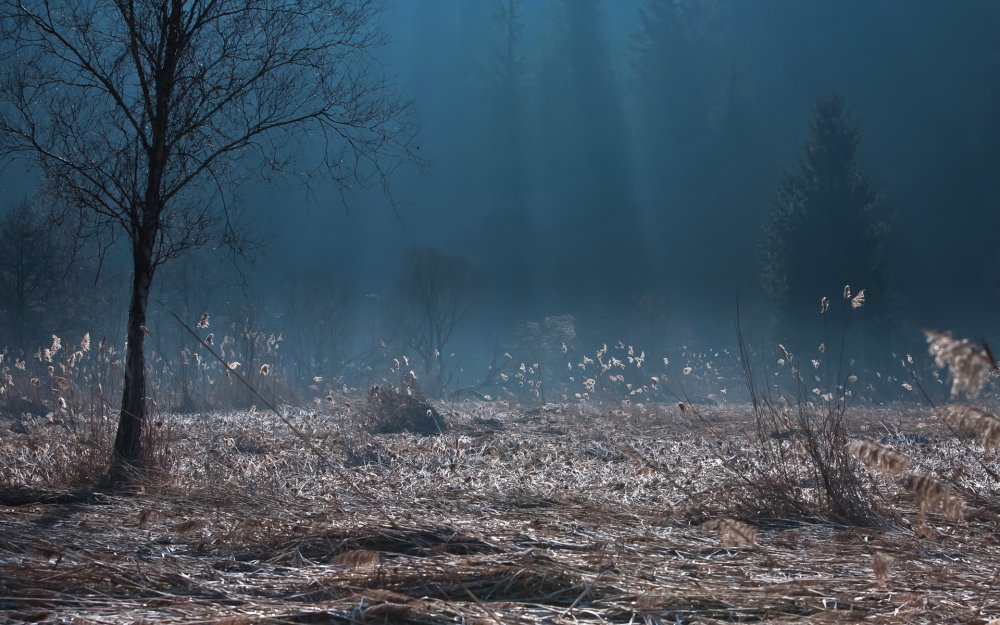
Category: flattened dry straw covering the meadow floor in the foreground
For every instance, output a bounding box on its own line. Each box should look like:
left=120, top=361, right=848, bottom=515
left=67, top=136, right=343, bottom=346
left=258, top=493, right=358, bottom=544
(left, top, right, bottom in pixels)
left=0, top=402, right=1000, bottom=623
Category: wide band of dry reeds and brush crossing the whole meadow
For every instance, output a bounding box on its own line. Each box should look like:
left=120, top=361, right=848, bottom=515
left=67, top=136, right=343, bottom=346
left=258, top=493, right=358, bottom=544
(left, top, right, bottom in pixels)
left=0, top=298, right=1000, bottom=544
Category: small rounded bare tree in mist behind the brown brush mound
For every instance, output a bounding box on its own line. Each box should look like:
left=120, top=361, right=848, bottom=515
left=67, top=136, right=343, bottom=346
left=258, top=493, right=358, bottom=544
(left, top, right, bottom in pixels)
left=399, top=247, right=475, bottom=395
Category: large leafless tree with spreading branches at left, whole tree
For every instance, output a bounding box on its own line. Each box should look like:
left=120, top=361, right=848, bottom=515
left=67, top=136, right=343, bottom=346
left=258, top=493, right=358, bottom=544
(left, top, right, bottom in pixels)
left=0, top=0, right=415, bottom=482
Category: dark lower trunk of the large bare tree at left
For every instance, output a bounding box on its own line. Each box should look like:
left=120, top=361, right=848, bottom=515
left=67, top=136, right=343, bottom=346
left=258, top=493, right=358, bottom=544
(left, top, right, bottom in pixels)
left=110, top=243, right=153, bottom=484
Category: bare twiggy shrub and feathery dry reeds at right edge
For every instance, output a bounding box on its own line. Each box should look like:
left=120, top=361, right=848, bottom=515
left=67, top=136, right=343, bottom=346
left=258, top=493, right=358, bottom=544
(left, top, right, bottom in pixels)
left=727, top=291, right=1000, bottom=537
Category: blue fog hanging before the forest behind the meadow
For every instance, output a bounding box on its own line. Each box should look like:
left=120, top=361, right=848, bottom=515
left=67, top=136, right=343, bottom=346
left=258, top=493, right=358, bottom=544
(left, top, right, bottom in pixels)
left=0, top=0, right=1000, bottom=400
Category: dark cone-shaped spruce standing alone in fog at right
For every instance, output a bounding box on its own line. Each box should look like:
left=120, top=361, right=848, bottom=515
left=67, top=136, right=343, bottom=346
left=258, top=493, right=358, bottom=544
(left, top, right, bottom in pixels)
left=759, top=96, right=890, bottom=332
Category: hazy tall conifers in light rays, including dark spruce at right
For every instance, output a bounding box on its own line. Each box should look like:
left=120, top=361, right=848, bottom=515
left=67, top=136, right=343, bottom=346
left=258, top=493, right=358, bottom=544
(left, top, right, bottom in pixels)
left=454, top=0, right=894, bottom=352
